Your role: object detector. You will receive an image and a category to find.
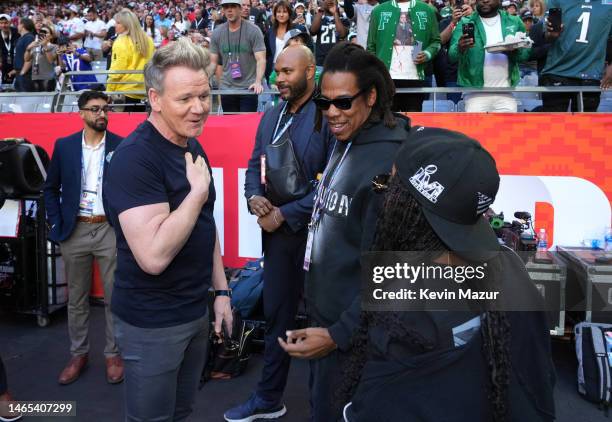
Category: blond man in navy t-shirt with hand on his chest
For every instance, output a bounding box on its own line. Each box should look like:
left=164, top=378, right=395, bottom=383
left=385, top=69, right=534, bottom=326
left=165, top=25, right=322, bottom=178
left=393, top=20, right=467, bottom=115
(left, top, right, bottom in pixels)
left=104, top=38, right=232, bottom=421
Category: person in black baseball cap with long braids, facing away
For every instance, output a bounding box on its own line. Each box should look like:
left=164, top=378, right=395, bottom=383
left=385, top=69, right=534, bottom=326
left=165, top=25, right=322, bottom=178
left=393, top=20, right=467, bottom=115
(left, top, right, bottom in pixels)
left=339, top=127, right=555, bottom=422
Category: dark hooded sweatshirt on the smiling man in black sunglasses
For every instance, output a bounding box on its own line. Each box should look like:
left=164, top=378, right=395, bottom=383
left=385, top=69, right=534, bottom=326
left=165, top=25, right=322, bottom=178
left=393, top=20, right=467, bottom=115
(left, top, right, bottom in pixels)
left=305, top=115, right=410, bottom=350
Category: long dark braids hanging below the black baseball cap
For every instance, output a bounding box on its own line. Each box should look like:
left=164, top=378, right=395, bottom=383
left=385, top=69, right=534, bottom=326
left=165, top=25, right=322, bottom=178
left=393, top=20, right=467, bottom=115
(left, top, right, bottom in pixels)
left=337, top=177, right=511, bottom=422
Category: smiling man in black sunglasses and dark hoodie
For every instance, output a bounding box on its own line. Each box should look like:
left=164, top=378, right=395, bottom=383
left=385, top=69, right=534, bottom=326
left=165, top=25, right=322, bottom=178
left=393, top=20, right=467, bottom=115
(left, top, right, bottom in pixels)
left=279, top=43, right=410, bottom=422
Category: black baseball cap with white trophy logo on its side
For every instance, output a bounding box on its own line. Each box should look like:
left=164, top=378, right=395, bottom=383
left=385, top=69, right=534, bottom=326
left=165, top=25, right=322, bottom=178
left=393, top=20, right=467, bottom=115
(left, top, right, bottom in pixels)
left=395, top=127, right=500, bottom=261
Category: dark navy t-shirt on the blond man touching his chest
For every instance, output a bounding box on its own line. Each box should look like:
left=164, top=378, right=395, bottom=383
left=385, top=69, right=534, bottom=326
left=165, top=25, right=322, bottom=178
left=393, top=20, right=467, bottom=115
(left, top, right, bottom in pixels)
left=104, top=121, right=216, bottom=328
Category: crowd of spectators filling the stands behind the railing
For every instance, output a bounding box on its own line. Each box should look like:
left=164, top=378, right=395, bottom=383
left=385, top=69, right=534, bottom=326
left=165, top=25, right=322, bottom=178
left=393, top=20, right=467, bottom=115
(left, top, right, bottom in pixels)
left=0, top=0, right=612, bottom=112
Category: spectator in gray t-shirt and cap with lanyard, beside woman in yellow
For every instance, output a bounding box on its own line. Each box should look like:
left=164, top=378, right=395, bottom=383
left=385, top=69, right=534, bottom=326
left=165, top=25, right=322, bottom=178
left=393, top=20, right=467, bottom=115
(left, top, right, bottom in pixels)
left=210, top=0, right=266, bottom=112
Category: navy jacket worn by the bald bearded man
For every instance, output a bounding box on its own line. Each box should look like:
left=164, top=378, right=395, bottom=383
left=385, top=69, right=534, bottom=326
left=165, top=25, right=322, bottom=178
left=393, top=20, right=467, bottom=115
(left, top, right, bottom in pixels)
left=244, top=100, right=333, bottom=232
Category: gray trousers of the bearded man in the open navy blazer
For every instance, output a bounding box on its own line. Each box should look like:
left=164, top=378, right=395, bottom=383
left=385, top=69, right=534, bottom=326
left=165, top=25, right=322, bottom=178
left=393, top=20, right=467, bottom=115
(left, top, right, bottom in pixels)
left=60, top=222, right=119, bottom=357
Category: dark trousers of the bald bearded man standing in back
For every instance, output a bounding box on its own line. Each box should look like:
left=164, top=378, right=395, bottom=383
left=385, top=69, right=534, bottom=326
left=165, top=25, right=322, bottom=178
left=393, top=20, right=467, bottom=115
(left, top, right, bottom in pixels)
left=257, top=230, right=307, bottom=403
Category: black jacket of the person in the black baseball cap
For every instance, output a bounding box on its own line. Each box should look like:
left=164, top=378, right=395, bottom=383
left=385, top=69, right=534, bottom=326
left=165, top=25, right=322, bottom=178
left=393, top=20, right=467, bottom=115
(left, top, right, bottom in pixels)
left=346, top=250, right=555, bottom=422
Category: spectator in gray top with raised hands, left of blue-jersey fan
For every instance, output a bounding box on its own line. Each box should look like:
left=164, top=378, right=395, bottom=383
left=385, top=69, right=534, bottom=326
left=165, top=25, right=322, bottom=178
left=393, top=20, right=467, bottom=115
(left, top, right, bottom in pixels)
left=24, top=24, right=58, bottom=92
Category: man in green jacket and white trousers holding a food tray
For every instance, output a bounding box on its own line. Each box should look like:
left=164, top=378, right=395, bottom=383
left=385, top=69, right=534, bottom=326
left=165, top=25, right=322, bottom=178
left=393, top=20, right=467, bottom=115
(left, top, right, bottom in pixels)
left=448, top=0, right=531, bottom=112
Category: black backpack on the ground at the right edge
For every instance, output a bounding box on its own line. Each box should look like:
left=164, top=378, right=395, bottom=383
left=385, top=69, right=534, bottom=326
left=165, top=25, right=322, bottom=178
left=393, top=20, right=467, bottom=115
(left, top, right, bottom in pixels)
left=574, top=322, right=612, bottom=415
